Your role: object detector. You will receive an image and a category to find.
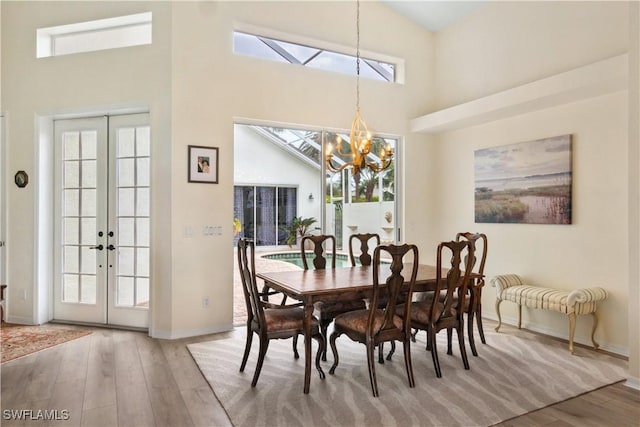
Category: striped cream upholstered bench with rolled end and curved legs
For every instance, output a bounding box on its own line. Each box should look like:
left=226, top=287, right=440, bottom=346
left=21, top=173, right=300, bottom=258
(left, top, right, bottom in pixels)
left=489, top=274, right=607, bottom=353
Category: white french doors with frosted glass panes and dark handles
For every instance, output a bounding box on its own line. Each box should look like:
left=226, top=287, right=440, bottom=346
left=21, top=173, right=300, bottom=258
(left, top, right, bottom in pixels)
left=54, top=114, right=151, bottom=328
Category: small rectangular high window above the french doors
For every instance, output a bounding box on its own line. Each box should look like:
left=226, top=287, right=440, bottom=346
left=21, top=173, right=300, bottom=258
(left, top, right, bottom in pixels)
left=36, top=12, right=152, bottom=58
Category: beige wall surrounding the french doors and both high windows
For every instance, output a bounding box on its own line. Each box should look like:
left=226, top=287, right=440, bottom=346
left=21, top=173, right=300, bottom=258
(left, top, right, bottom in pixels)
left=0, top=1, right=433, bottom=338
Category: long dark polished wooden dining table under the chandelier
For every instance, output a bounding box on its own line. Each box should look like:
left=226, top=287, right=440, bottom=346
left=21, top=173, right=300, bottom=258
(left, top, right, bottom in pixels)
left=256, top=264, right=436, bottom=394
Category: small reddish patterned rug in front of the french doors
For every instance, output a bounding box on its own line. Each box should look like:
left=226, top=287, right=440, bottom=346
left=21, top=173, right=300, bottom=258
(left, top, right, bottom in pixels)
left=0, top=323, right=91, bottom=363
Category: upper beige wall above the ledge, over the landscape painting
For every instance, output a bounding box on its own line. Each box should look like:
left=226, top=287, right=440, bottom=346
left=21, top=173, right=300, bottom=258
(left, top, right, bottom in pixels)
left=432, top=1, right=629, bottom=108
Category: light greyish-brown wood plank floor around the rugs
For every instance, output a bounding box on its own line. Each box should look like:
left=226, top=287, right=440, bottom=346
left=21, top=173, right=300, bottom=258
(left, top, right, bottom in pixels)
left=0, top=326, right=640, bottom=427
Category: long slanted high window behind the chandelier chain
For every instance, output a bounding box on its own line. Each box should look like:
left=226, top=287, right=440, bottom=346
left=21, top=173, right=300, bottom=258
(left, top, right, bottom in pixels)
left=233, top=31, right=396, bottom=82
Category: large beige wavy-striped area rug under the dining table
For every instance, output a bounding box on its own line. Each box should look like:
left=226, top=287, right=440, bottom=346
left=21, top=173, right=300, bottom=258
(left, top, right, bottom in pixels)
left=188, top=330, right=627, bottom=427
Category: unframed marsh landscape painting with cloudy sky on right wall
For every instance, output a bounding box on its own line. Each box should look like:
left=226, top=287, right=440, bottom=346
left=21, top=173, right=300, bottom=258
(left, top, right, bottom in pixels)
left=474, top=135, right=571, bottom=224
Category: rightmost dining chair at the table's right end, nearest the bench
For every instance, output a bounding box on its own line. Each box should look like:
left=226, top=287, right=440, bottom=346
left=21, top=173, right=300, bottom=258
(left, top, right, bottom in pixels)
left=447, top=232, right=488, bottom=356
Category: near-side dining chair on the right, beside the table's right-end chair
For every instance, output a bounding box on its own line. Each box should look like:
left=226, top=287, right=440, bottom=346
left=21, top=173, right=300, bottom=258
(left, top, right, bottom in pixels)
left=400, top=241, right=473, bottom=378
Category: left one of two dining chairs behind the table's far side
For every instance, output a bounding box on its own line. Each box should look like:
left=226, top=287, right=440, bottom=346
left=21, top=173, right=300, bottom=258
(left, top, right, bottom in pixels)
left=300, top=234, right=366, bottom=360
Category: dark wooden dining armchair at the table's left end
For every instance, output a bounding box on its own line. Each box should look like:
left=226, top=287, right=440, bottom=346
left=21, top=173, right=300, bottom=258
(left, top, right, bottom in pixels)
left=238, top=238, right=326, bottom=387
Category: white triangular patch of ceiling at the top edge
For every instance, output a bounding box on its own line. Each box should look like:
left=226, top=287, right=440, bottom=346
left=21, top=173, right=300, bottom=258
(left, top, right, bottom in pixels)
left=382, top=0, right=487, bottom=32
